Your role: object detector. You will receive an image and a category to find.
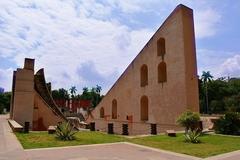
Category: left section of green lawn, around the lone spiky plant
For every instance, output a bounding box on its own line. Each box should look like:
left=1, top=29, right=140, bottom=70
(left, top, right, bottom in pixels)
left=15, top=132, right=125, bottom=149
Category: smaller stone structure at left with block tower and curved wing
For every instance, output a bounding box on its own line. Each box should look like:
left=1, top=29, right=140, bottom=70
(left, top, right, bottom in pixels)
left=10, top=58, right=66, bottom=131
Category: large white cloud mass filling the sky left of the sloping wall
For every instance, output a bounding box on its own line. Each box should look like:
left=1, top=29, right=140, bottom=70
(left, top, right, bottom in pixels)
left=0, top=1, right=152, bottom=92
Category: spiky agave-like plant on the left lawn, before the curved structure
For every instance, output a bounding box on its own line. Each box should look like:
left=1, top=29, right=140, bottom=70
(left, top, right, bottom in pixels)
left=56, top=122, right=76, bottom=141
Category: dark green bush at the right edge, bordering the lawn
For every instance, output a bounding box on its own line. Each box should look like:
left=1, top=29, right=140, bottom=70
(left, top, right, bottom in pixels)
left=214, top=112, right=240, bottom=135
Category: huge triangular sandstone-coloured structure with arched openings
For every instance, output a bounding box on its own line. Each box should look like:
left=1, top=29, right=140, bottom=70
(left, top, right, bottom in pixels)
left=88, top=5, right=199, bottom=134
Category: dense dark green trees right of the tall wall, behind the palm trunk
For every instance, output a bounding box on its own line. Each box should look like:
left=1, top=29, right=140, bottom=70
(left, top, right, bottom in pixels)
left=199, top=77, right=240, bottom=114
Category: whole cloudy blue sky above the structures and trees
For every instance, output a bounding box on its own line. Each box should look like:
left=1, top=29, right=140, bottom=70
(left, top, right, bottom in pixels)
left=0, top=0, right=240, bottom=93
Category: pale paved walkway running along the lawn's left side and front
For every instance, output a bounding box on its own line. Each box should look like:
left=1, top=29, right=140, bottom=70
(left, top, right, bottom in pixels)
left=0, top=115, right=240, bottom=160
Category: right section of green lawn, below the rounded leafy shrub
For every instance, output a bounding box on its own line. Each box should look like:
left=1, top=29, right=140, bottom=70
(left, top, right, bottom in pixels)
left=129, top=134, right=240, bottom=158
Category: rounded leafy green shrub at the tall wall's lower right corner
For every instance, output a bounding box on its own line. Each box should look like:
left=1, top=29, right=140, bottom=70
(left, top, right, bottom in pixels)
left=177, top=111, right=200, bottom=133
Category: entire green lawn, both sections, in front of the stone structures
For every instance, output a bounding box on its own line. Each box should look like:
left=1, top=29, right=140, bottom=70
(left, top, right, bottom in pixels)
left=16, top=132, right=240, bottom=158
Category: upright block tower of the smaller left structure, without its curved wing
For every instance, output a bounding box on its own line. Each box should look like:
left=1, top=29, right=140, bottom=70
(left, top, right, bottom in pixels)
left=11, top=58, right=35, bottom=128
